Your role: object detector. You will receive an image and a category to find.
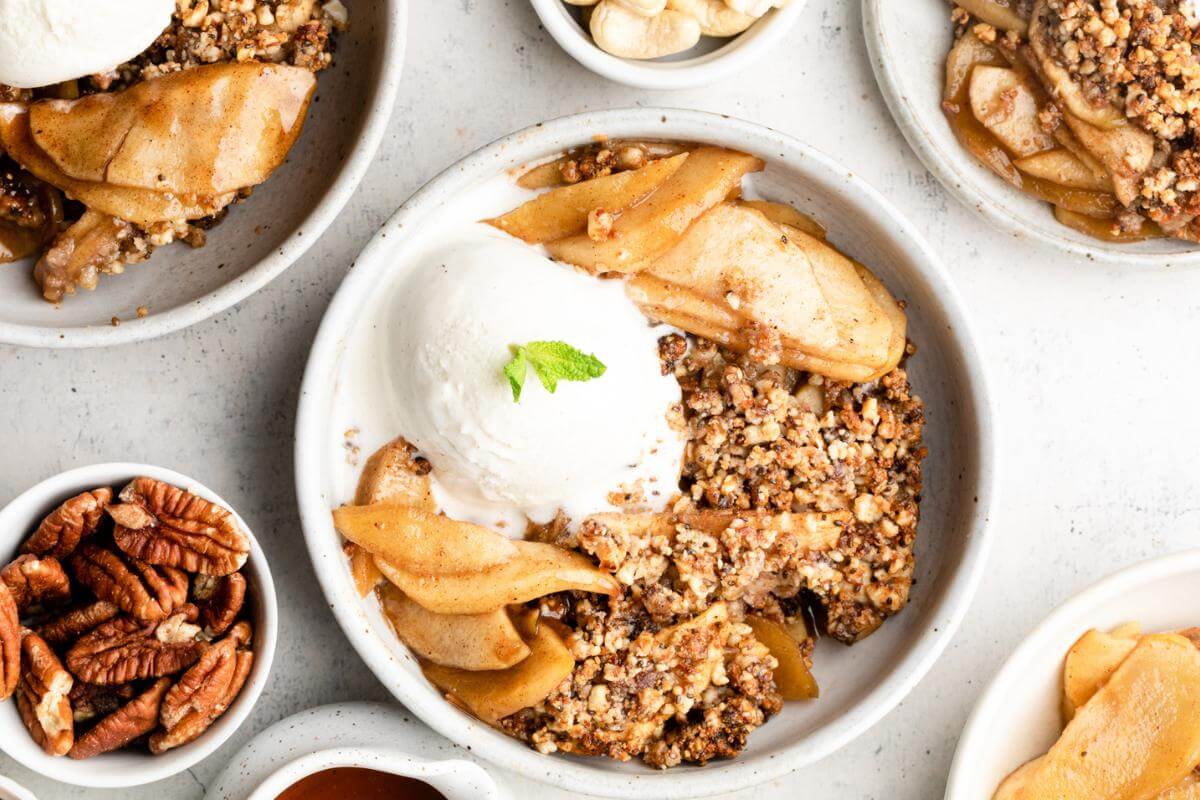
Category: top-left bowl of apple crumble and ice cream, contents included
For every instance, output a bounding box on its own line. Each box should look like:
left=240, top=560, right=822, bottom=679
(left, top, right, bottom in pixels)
left=0, top=0, right=406, bottom=347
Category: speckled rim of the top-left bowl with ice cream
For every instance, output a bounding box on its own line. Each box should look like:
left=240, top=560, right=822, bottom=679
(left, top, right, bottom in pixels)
left=0, top=0, right=408, bottom=348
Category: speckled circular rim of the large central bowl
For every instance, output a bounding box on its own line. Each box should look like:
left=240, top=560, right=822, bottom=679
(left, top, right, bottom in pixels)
left=295, top=108, right=996, bottom=800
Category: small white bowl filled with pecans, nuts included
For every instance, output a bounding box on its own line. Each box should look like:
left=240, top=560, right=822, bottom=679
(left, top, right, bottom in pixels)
left=0, top=463, right=277, bottom=788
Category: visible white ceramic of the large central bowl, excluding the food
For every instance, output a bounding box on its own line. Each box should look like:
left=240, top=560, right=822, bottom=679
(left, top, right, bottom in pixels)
left=296, top=108, right=995, bottom=800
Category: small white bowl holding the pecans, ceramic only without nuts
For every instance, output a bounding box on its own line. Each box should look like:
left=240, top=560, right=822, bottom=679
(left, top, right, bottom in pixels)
left=0, top=463, right=278, bottom=788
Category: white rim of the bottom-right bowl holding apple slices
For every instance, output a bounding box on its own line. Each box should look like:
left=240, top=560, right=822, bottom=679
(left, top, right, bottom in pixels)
left=946, top=549, right=1200, bottom=800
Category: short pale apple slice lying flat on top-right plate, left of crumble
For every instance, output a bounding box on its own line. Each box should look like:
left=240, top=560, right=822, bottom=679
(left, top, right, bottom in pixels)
left=970, top=65, right=1055, bottom=157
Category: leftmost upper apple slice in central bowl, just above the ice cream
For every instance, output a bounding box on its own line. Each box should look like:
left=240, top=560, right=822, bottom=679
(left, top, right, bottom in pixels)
left=486, top=152, right=688, bottom=245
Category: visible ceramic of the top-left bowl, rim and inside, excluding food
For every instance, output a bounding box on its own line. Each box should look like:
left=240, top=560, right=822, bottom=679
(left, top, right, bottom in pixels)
left=0, top=0, right=408, bottom=348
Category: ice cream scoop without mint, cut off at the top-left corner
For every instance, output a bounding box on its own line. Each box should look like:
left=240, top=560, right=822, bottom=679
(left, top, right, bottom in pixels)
left=0, top=0, right=175, bottom=89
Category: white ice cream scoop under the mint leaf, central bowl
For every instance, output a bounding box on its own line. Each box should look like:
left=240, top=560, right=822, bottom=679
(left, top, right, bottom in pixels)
left=383, top=225, right=684, bottom=535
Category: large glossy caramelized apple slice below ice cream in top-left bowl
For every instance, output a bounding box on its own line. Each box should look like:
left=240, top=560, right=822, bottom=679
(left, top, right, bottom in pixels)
left=30, top=61, right=317, bottom=194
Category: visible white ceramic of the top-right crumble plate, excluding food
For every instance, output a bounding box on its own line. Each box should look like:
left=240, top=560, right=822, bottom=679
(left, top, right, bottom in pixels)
left=863, top=0, right=1200, bottom=267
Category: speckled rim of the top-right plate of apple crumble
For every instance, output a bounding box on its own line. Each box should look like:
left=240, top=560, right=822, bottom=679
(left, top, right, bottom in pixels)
left=863, top=0, right=1200, bottom=267
